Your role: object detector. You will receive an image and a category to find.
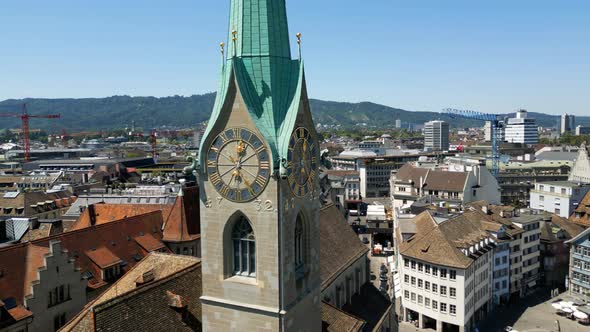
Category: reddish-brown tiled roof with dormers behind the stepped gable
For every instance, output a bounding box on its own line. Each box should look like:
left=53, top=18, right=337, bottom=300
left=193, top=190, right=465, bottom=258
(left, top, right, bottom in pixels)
left=0, top=211, right=165, bottom=304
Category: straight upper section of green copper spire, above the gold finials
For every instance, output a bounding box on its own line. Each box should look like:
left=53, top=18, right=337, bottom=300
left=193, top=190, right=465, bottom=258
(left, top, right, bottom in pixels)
left=228, top=0, right=291, bottom=59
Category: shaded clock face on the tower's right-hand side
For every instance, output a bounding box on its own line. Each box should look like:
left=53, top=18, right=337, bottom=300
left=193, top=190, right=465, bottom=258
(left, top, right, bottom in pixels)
left=287, top=127, right=318, bottom=197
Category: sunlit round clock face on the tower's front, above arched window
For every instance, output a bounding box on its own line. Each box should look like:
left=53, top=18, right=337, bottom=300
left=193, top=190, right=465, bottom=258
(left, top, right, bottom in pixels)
left=207, top=128, right=270, bottom=203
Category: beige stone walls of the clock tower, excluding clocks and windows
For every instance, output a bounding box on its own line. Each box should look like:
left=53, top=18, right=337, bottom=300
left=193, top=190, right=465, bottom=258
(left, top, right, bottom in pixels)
left=200, top=76, right=321, bottom=331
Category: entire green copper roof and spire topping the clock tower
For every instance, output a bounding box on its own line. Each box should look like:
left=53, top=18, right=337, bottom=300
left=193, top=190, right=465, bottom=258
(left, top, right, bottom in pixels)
left=201, top=0, right=303, bottom=167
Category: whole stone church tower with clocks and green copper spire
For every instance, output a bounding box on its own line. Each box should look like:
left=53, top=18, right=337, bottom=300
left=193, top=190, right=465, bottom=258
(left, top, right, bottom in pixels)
left=199, top=0, right=322, bottom=332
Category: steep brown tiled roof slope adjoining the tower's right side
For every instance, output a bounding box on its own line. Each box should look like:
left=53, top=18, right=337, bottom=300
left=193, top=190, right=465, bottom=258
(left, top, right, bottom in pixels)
left=320, top=203, right=369, bottom=289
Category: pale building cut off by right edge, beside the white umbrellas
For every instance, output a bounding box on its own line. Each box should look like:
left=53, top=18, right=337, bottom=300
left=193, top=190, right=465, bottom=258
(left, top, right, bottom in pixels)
left=566, top=228, right=590, bottom=302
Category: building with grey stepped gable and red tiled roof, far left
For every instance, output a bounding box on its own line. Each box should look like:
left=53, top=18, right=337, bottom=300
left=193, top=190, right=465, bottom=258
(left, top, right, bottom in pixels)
left=0, top=212, right=168, bottom=332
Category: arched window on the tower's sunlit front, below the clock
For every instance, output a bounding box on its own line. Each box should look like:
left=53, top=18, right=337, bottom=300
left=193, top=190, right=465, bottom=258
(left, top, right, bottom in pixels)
left=232, top=216, right=256, bottom=277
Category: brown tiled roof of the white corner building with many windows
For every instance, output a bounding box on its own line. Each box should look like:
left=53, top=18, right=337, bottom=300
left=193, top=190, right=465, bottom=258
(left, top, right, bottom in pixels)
left=400, top=211, right=488, bottom=269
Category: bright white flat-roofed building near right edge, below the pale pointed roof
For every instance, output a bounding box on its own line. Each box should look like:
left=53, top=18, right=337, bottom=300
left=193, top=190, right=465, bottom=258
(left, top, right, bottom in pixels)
left=530, top=181, right=590, bottom=218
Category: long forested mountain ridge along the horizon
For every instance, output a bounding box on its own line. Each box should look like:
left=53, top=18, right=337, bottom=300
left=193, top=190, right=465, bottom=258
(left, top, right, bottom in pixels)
left=0, top=93, right=590, bottom=132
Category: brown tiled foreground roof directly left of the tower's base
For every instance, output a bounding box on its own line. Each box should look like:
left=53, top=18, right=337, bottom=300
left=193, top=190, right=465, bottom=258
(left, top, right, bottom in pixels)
left=60, top=252, right=201, bottom=332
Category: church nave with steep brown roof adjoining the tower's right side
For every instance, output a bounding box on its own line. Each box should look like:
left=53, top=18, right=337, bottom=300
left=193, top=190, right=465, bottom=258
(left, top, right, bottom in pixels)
left=322, top=204, right=398, bottom=332
